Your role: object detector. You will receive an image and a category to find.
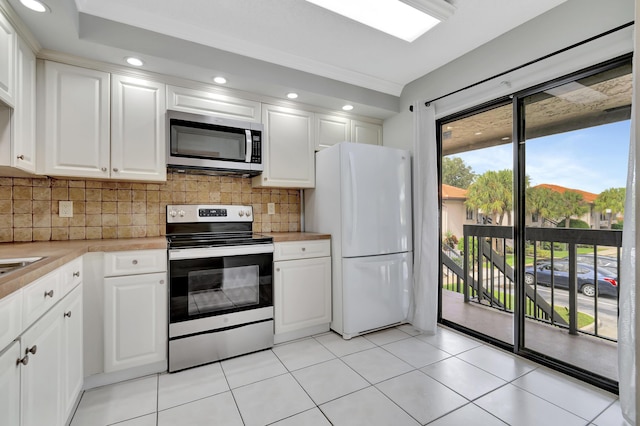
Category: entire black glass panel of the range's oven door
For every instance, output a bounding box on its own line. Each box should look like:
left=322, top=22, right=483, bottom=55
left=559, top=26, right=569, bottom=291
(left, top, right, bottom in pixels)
left=169, top=253, right=273, bottom=323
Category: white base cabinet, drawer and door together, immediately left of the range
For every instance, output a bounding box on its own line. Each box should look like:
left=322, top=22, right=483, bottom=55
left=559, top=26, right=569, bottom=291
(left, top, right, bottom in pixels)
left=104, top=250, right=167, bottom=373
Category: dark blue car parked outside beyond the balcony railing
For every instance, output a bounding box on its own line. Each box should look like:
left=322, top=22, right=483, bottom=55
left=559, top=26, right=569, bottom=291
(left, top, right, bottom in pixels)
left=524, top=260, right=618, bottom=297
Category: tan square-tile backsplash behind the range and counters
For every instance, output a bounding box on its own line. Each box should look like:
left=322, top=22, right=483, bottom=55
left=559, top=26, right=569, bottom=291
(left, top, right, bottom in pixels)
left=0, top=173, right=300, bottom=242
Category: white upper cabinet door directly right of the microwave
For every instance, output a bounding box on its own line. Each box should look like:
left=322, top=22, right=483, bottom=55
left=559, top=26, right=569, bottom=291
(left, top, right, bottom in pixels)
left=253, top=105, right=315, bottom=188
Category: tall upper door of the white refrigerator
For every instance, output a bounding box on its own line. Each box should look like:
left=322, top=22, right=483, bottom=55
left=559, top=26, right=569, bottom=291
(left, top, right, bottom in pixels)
left=340, top=144, right=413, bottom=257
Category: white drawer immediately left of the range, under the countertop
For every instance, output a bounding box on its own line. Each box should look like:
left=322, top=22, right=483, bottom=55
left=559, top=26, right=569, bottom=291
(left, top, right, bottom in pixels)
left=104, top=250, right=167, bottom=277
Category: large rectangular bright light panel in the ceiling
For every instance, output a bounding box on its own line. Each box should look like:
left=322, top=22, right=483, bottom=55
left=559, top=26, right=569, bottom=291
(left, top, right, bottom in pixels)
left=307, top=0, right=455, bottom=42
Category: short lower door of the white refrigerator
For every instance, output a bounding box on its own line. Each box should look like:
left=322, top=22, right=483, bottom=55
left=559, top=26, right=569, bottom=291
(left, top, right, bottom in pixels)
left=342, top=252, right=412, bottom=337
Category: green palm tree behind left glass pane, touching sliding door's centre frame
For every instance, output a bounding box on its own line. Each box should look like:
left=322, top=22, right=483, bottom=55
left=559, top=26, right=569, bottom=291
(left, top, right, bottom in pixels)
left=465, top=169, right=513, bottom=225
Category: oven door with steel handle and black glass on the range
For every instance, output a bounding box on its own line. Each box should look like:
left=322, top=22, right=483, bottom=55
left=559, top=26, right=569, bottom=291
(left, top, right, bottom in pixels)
left=169, top=244, right=273, bottom=337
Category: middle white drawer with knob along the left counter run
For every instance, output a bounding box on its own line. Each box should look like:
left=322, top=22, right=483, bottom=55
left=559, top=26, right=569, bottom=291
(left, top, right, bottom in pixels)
left=22, top=268, right=62, bottom=329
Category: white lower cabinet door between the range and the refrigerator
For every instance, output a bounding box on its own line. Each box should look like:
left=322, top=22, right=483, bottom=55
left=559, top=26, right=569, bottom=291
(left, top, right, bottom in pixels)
left=274, top=257, right=331, bottom=334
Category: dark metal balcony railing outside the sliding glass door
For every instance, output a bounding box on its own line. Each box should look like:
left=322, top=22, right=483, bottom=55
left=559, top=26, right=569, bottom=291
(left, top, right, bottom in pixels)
left=442, top=225, right=622, bottom=341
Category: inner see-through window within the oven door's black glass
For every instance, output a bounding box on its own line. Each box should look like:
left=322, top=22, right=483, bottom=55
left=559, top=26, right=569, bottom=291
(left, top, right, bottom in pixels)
left=188, top=265, right=260, bottom=316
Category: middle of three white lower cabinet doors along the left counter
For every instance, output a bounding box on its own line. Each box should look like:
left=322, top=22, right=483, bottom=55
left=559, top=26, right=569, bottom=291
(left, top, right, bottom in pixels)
left=20, top=307, right=62, bottom=426
